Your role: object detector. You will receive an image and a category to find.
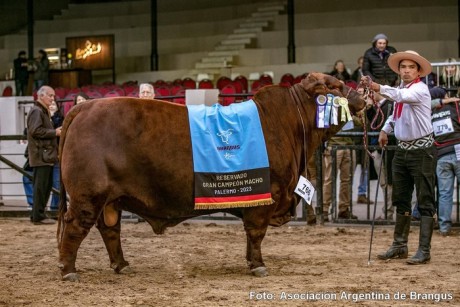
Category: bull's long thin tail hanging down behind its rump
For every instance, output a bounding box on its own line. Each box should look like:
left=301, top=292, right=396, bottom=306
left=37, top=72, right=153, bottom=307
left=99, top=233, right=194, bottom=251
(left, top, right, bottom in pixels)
left=56, top=105, right=82, bottom=248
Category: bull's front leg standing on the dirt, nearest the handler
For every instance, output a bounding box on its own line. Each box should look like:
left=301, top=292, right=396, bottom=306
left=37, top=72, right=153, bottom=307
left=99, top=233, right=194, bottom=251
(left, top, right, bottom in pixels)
left=244, top=219, right=268, bottom=277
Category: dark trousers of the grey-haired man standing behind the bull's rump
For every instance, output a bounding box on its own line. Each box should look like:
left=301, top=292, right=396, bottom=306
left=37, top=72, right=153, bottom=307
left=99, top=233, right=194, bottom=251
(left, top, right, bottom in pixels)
left=32, top=166, right=53, bottom=222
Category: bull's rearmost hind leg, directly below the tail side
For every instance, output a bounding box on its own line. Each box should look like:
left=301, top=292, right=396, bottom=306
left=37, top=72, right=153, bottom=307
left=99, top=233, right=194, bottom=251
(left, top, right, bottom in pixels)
left=59, top=206, right=98, bottom=281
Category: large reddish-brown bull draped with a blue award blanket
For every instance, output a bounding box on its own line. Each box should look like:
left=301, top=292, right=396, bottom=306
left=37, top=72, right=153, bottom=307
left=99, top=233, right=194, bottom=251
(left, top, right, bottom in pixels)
left=57, top=73, right=365, bottom=281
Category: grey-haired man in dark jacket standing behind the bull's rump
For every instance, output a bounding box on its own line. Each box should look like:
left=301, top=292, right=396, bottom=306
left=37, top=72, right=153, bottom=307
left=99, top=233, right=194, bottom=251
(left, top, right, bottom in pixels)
left=27, top=86, right=61, bottom=225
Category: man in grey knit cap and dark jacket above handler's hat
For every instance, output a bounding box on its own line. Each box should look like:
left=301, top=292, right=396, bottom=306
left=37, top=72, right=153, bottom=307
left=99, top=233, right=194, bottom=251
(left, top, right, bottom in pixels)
left=363, top=34, right=398, bottom=86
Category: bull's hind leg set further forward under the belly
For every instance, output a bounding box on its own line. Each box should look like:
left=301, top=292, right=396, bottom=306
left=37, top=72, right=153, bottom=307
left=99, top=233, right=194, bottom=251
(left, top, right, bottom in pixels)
left=96, top=207, right=132, bottom=273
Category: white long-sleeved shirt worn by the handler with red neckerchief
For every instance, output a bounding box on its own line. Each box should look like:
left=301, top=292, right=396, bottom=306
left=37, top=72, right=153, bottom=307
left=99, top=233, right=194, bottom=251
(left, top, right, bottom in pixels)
left=380, top=81, right=433, bottom=141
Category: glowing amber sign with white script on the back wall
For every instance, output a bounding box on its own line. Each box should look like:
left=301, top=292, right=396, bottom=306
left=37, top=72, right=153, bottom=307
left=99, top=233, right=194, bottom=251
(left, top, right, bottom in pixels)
left=66, top=35, right=115, bottom=70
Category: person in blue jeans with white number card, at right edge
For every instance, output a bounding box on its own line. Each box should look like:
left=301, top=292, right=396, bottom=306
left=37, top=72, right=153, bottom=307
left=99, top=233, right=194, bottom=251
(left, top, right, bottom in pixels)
left=430, top=87, right=460, bottom=236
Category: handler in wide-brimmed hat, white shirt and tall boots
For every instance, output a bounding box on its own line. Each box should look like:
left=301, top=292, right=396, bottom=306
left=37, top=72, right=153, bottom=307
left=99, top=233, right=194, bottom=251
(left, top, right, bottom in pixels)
left=361, top=50, right=436, bottom=264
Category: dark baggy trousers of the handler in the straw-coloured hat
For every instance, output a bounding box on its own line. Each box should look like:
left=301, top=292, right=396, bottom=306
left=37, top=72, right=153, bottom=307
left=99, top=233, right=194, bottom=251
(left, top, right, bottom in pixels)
left=392, top=147, right=436, bottom=217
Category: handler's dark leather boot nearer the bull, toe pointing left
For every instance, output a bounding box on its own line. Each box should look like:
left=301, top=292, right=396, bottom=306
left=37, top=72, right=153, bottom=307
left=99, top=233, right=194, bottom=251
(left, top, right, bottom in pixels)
left=377, top=214, right=411, bottom=260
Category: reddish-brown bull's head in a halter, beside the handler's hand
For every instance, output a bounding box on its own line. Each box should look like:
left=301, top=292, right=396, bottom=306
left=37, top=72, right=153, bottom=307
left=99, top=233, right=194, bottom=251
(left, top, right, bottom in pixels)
left=302, top=72, right=366, bottom=114
